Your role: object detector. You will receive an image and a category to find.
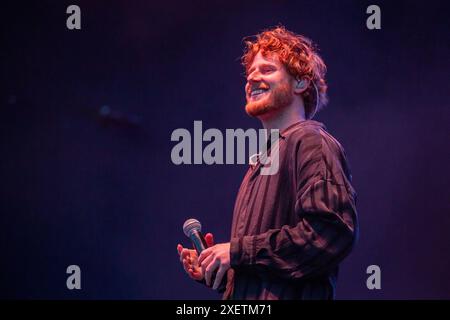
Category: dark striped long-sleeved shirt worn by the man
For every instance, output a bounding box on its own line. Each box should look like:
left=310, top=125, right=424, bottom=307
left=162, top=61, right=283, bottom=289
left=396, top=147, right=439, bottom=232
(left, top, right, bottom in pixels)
left=223, top=120, right=358, bottom=300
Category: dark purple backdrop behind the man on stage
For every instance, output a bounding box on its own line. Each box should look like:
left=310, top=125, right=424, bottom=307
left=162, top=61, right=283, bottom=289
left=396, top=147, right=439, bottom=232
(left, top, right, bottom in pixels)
left=0, top=1, right=450, bottom=299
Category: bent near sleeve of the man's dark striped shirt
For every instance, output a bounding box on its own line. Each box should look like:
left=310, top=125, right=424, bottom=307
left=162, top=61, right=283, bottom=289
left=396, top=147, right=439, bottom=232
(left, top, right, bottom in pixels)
left=230, top=133, right=357, bottom=279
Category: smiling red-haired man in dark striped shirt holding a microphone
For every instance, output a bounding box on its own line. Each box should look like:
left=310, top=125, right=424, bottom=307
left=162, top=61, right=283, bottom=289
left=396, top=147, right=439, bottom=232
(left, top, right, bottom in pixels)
left=177, top=26, right=358, bottom=299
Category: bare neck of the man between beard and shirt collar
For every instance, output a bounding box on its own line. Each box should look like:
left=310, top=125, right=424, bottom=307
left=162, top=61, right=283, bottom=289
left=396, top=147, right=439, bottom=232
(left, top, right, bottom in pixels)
left=259, top=105, right=305, bottom=132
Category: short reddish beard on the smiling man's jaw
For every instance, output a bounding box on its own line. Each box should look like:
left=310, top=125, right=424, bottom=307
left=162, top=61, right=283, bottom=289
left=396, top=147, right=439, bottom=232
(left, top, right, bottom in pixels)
left=245, top=82, right=294, bottom=117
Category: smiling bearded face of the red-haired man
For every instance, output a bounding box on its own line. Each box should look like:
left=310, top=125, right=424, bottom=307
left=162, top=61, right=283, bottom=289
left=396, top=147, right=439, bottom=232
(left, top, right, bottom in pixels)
left=245, top=52, right=294, bottom=117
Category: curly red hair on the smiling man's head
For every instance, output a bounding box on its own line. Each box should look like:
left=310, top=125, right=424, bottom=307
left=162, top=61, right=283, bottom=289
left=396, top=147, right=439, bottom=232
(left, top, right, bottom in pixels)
left=242, top=26, right=328, bottom=119
